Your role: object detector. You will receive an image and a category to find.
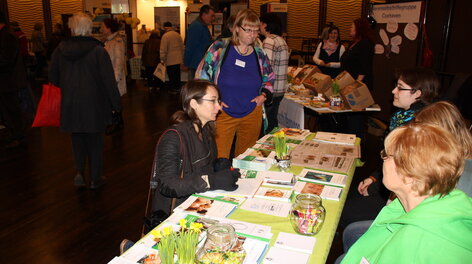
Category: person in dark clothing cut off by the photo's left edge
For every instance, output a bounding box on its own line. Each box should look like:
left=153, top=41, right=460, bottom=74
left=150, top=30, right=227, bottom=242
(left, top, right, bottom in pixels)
left=0, top=12, right=27, bottom=148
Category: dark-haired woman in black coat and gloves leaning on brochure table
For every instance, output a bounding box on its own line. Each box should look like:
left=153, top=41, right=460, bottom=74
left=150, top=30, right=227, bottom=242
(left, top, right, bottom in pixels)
left=152, top=80, right=240, bottom=219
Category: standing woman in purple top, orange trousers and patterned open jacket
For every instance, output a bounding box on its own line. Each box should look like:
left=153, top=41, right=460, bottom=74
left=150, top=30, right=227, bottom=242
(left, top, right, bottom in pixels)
left=195, top=9, right=275, bottom=158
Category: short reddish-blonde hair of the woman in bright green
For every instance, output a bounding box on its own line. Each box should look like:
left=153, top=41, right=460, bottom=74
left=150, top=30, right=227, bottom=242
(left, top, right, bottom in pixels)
left=385, top=123, right=464, bottom=196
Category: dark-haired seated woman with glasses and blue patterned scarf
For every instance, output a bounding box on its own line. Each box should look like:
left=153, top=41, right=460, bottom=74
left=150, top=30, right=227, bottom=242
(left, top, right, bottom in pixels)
left=340, top=67, right=440, bottom=226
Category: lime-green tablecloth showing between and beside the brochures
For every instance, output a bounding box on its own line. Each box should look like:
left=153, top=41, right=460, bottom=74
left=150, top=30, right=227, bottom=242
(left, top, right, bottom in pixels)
left=109, top=134, right=362, bottom=264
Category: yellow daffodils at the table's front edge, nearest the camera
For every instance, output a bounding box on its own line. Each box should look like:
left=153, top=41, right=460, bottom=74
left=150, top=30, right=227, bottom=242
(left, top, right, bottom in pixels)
left=151, top=219, right=203, bottom=264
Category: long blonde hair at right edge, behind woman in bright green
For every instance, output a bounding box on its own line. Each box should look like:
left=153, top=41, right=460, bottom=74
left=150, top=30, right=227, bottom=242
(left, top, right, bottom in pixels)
left=415, top=101, right=472, bottom=158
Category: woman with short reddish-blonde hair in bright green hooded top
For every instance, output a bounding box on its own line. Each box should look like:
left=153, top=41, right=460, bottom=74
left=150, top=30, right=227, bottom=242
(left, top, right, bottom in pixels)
left=341, top=123, right=472, bottom=263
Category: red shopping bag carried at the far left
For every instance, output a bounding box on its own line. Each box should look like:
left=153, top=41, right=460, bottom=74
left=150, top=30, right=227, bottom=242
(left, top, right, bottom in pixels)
left=33, top=83, right=61, bottom=127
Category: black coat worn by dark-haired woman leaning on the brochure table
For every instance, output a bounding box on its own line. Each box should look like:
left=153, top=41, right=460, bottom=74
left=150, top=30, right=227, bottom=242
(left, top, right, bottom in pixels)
left=152, top=121, right=217, bottom=214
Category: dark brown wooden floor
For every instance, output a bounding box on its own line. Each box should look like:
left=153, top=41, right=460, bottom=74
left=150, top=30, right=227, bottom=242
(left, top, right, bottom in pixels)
left=0, top=81, right=382, bottom=264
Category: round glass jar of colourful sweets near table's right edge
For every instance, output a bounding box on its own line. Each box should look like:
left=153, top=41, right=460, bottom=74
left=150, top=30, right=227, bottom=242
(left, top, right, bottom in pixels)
left=290, top=193, right=326, bottom=236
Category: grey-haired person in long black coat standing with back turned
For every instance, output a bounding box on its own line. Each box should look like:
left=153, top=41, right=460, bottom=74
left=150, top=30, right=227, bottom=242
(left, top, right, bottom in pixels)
left=49, top=13, right=121, bottom=189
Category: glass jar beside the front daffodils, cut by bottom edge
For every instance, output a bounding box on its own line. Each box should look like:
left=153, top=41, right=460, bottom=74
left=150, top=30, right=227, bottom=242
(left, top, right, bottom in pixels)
left=197, top=224, right=246, bottom=264
